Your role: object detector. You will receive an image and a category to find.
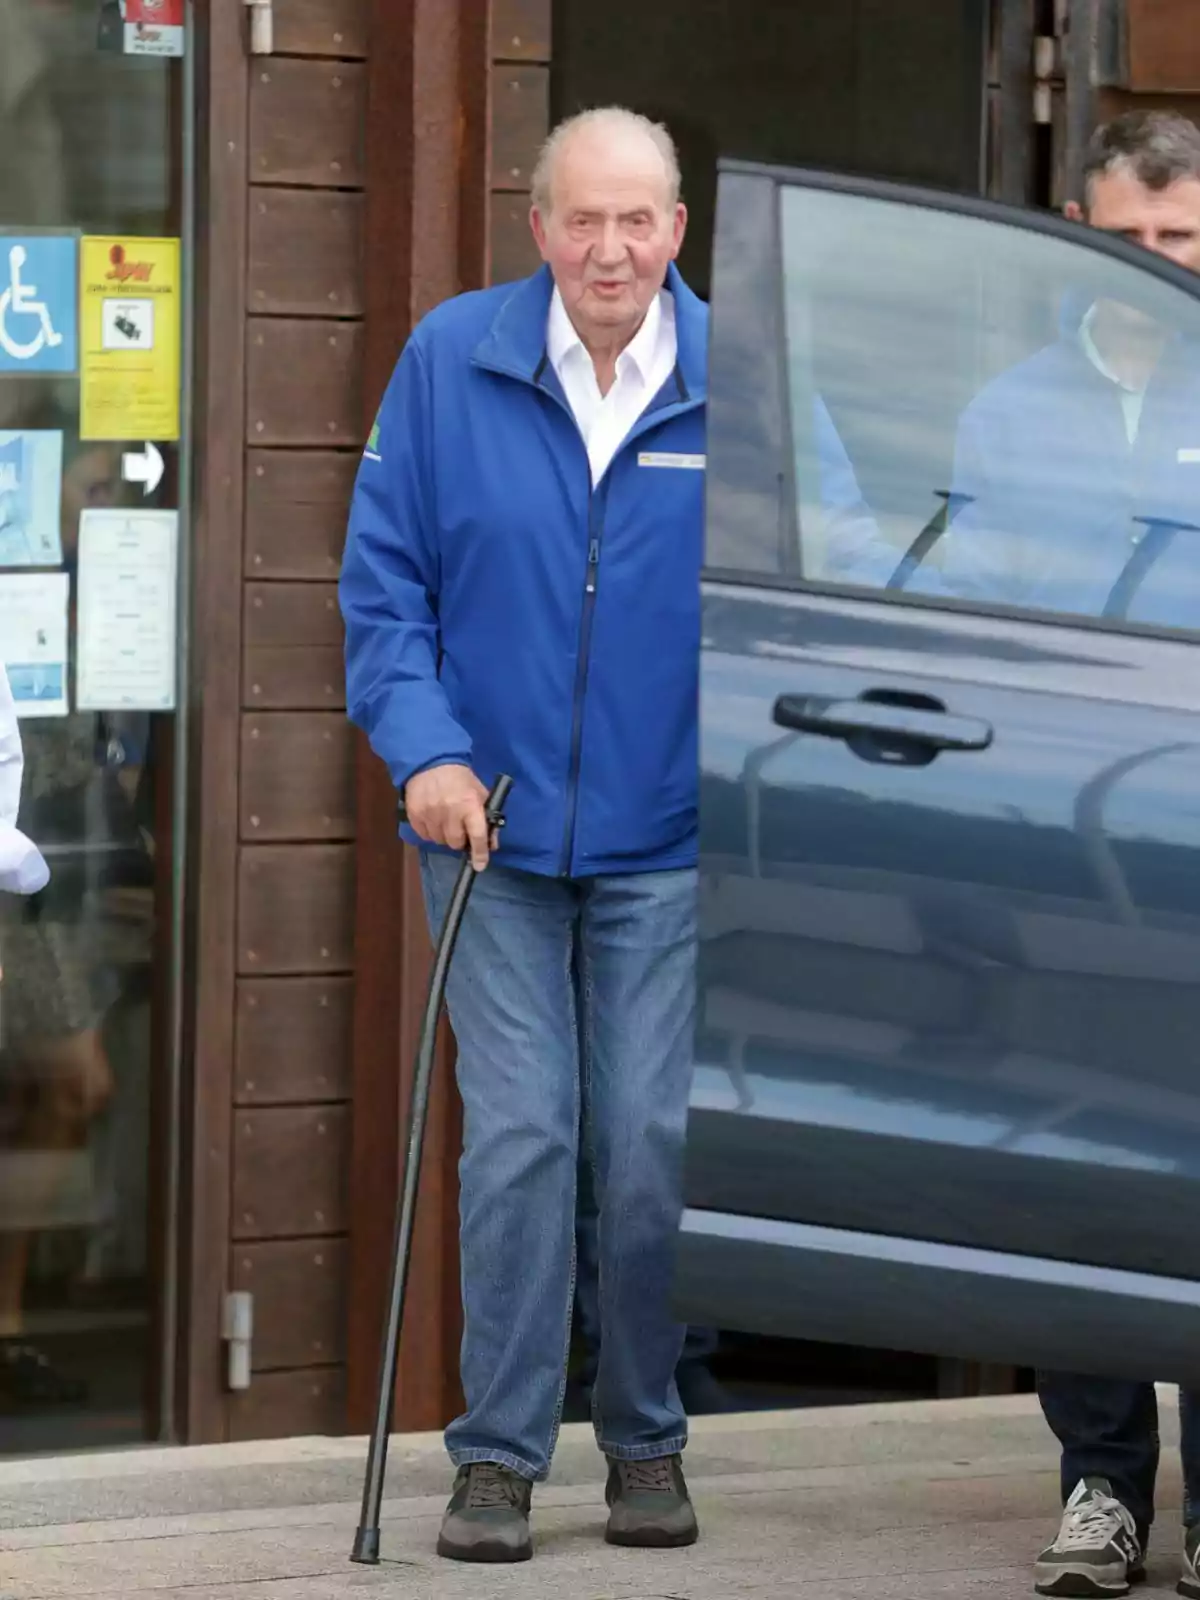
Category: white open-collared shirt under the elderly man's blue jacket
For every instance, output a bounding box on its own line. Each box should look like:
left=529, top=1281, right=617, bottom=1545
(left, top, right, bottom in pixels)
left=546, top=290, right=677, bottom=485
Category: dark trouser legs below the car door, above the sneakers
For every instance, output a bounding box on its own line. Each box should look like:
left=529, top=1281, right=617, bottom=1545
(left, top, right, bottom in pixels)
left=1037, top=1373, right=1200, bottom=1538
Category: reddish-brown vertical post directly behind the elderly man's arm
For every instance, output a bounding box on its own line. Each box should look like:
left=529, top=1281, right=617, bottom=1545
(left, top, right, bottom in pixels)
left=347, top=0, right=491, bottom=1432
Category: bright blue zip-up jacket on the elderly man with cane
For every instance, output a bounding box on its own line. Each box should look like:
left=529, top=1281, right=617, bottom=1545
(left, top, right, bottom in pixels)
left=339, top=267, right=707, bottom=877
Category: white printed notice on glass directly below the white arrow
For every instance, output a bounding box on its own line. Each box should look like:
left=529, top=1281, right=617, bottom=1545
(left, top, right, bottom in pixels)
left=75, top=510, right=179, bottom=710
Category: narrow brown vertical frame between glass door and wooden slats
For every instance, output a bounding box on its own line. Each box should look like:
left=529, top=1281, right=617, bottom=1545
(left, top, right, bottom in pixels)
left=178, top=0, right=250, bottom=1443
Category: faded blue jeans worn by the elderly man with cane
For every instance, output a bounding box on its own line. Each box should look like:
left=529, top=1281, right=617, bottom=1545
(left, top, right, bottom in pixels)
left=421, top=851, right=696, bottom=1478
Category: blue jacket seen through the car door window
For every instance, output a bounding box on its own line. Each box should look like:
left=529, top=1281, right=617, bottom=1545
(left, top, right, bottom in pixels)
left=934, top=310, right=1200, bottom=627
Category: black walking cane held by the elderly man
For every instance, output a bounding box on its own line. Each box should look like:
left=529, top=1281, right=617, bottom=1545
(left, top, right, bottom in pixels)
left=350, top=776, right=512, bottom=1566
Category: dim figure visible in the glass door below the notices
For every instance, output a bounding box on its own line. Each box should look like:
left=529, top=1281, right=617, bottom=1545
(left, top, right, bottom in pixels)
left=0, top=443, right=149, bottom=1410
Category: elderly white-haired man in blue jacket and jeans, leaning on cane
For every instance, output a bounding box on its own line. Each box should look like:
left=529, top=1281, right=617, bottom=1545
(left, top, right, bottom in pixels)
left=341, top=107, right=707, bottom=1562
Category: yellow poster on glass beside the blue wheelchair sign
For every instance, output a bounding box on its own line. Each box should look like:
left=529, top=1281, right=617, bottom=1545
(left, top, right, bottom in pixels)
left=80, top=238, right=181, bottom=440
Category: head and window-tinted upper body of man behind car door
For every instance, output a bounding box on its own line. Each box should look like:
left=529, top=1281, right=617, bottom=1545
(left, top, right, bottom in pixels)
left=934, top=112, right=1200, bottom=627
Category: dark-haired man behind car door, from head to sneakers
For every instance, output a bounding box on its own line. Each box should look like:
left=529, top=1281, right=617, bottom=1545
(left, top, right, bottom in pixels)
left=934, top=112, right=1200, bottom=1597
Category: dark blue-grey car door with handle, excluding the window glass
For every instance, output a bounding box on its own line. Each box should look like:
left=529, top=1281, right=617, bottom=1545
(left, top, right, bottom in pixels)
left=678, top=168, right=1200, bottom=1382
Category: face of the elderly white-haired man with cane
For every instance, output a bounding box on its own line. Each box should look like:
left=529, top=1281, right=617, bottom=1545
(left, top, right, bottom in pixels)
left=530, top=130, right=688, bottom=341
